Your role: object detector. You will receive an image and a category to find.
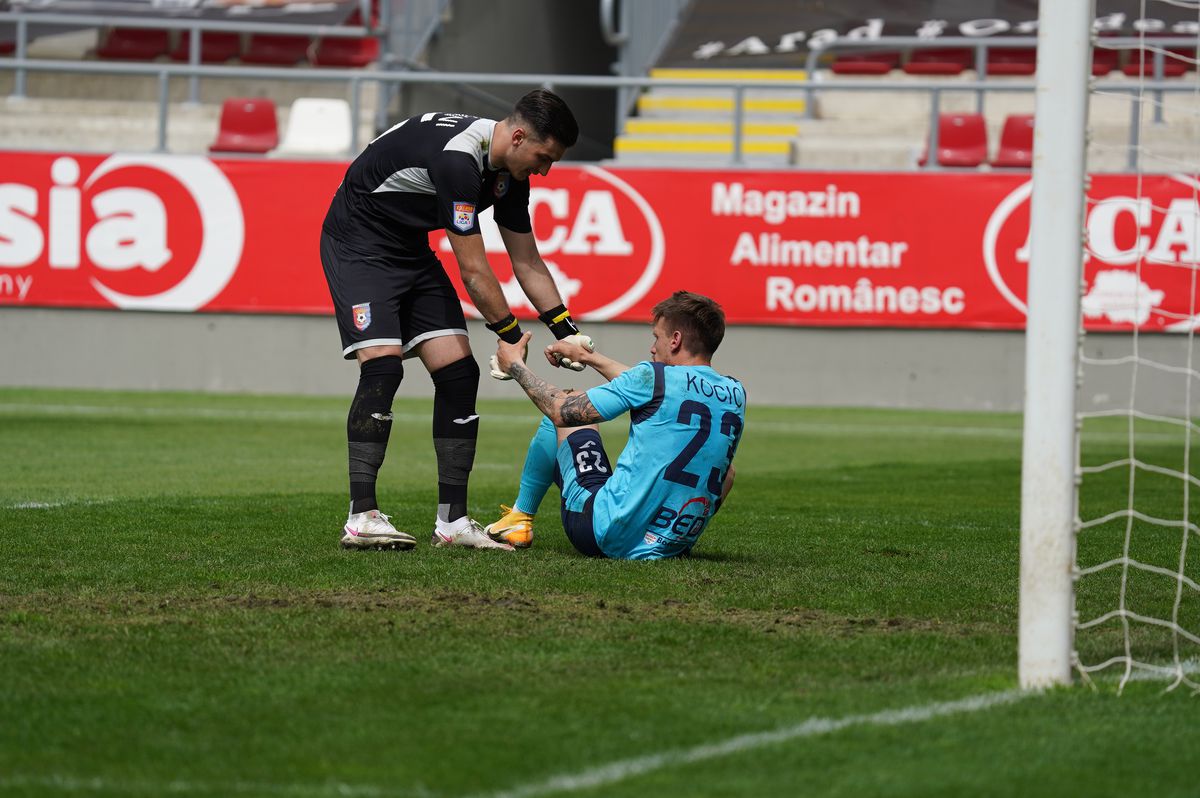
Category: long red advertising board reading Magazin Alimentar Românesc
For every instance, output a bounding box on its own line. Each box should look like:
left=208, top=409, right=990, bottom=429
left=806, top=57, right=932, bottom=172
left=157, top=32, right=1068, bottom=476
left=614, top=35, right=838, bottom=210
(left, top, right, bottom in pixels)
left=0, top=152, right=1200, bottom=330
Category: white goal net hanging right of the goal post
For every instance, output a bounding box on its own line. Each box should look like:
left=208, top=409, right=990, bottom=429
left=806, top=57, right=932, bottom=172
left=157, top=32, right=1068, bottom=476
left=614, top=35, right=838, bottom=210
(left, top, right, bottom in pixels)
left=1072, top=0, right=1200, bottom=690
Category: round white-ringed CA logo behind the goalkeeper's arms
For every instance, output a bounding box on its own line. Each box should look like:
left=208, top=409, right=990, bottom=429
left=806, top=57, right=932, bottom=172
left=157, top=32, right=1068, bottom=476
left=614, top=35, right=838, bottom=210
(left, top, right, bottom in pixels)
left=441, top=167, right=666, bottom=320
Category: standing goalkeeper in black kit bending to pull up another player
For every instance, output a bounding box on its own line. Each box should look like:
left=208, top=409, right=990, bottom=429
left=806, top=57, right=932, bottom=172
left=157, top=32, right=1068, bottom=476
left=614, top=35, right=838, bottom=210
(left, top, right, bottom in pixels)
left=320, top=90, right=590, bottom=551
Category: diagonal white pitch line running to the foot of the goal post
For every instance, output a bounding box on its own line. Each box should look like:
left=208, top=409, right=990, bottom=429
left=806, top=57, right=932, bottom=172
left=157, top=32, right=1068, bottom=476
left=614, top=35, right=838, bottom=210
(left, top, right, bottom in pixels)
left=463, top=690, right=1036, bottom=798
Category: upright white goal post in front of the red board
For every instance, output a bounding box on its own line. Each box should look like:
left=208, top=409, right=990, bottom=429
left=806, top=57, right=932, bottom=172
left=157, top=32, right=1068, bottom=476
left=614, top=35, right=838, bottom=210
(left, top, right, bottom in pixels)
left=1018, top=0, right=1096, bottom=688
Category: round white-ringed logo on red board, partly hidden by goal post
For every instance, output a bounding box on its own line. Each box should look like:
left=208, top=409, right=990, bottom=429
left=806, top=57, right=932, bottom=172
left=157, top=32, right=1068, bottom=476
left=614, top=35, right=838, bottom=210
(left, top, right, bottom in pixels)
left=983, top=175, right=1200, bottom=331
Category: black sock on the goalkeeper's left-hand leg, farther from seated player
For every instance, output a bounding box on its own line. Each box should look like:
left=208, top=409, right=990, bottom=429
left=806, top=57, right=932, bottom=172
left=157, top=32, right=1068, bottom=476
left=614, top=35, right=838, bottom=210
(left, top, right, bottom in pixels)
left=346, top=355, right=404, bottom=514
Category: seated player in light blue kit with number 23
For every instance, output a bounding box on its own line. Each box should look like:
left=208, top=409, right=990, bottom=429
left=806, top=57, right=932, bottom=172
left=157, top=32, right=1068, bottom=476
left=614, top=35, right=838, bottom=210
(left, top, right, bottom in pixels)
left=487, top=290, right=746, bottom=559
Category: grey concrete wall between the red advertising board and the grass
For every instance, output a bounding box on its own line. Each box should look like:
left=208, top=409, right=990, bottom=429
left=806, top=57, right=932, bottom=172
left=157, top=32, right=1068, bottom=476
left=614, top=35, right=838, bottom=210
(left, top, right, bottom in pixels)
left=0, top=307, right=1200, bottom=415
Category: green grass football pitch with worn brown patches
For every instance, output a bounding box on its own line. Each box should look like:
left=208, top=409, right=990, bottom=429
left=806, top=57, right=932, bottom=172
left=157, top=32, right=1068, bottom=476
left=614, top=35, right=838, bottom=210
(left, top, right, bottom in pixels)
left=0, top=389, right=1200, bottom=798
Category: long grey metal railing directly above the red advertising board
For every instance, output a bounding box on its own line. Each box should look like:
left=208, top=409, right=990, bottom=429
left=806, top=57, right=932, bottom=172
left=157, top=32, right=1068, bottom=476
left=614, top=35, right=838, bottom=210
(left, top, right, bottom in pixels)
left=0, top=33, right=1198, bottom=169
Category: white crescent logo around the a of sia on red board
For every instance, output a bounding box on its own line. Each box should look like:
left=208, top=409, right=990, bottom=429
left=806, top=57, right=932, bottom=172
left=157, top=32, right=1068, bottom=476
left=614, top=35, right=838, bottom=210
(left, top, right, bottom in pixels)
left=83, top=155, right=245, bottom=311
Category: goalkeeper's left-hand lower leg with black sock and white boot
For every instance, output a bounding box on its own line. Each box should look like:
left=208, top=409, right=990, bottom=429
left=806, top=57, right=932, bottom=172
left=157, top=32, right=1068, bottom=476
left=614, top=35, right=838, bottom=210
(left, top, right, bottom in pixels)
left=342, top=347, right=416, bottom=550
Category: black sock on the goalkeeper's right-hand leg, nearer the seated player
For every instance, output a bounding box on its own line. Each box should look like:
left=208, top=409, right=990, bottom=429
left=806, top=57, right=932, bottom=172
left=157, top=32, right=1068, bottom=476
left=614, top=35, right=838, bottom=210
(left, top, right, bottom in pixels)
left=430, top=356, right=479, bottom=522
